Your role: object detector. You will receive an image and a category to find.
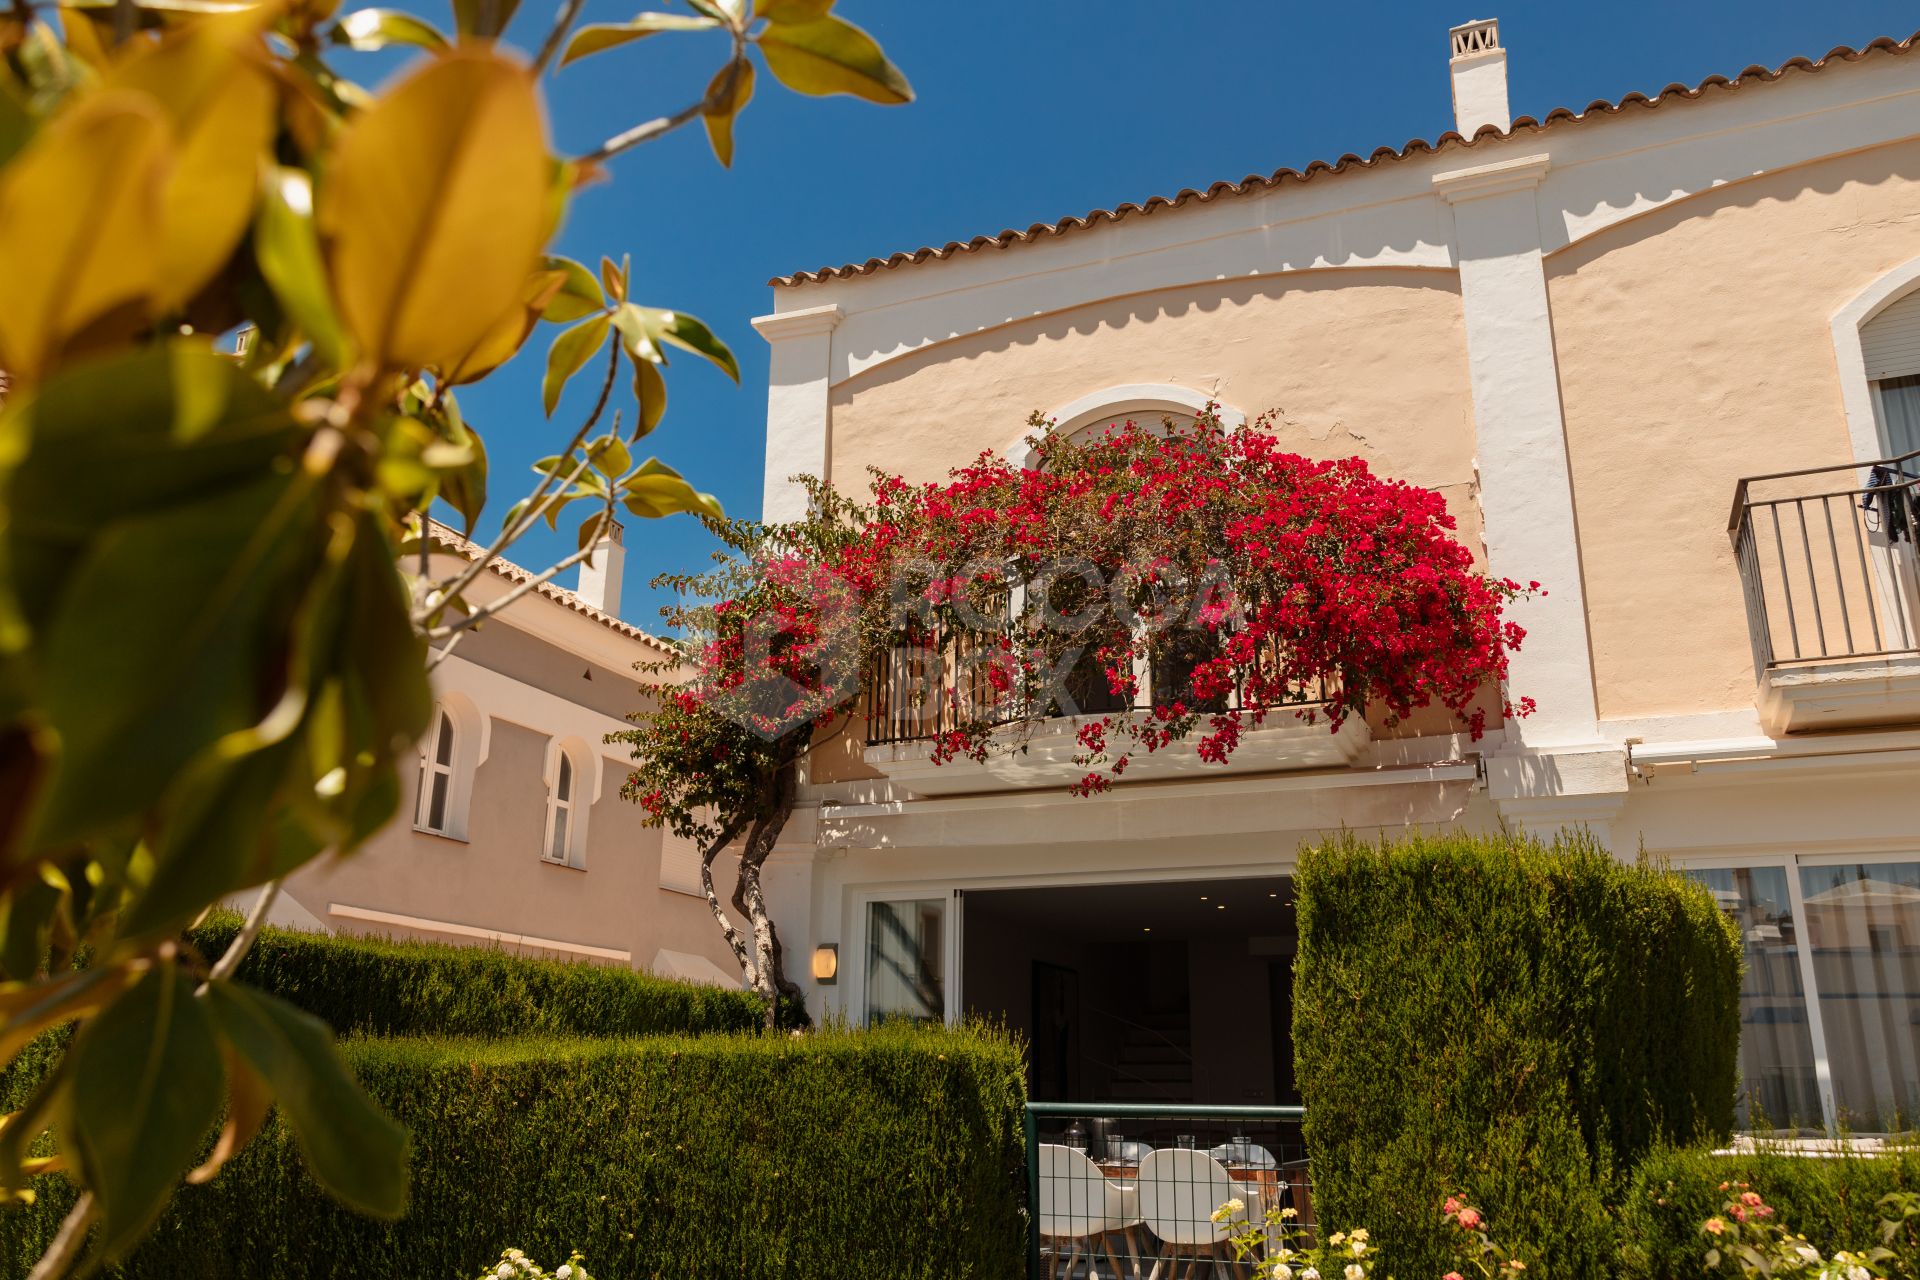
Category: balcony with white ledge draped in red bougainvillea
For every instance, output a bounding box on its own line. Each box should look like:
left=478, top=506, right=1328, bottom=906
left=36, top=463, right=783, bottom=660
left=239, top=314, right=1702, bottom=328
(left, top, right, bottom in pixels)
left=866, top=629, right=1371, bottom=794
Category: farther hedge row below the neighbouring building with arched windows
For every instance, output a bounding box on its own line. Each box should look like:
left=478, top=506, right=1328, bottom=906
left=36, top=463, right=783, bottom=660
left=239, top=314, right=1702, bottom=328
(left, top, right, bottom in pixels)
left=188, top=912, right=762, bottom=1036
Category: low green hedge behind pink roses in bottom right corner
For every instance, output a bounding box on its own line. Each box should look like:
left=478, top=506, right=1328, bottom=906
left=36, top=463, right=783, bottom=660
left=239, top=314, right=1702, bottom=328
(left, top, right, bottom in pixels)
left=1620, top=1150, right=1920, bottom=1280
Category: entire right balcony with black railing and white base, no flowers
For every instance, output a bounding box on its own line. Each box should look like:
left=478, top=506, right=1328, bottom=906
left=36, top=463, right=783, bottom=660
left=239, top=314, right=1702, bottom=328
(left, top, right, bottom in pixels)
left=1728, top=453, right=1920, bottom=735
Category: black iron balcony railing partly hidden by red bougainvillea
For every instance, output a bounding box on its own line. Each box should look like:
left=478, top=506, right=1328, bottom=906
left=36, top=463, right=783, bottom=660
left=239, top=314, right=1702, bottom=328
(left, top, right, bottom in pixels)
left=864, top=628, right=1331, bottom=747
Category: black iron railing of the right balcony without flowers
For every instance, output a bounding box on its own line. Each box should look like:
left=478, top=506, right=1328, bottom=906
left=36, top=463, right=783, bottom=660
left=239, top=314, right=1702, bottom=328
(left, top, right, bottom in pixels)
left=1728, top=451, right=1920, bottom=674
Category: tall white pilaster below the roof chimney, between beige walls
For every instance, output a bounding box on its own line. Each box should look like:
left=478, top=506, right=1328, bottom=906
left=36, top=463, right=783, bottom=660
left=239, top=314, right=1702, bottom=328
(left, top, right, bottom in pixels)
left=1434, top=155, right=1599, bottom=748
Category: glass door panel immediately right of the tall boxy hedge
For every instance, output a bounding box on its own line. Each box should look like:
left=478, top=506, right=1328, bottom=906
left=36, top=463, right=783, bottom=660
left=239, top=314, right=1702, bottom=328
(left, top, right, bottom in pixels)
left=1690, top=865, right=1826, bottom=1132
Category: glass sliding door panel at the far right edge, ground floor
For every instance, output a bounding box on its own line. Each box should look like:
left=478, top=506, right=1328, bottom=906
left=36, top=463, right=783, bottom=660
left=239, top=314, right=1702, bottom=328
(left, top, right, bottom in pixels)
left=1799, top=862, right=1920, bottom=1132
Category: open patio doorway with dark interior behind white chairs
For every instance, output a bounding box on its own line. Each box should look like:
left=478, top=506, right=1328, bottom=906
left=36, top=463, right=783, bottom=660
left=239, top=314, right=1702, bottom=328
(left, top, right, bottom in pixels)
left=960, top=875, right=1300, bottom=1105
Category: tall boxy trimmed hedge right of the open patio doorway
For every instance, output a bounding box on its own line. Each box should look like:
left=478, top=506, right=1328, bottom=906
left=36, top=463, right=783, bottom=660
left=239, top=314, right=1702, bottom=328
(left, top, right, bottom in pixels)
left=1294, top=835, right=1741, bottom=1276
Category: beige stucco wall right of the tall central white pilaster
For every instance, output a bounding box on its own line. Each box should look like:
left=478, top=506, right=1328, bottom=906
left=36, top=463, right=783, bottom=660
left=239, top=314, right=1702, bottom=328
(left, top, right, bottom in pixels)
left=1548, top=142, right=1920, bottom=718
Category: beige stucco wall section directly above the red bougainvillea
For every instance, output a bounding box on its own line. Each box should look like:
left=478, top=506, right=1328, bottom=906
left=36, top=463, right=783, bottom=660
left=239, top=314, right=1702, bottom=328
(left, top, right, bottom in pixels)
left=831, top=269, right=1478, bottom=514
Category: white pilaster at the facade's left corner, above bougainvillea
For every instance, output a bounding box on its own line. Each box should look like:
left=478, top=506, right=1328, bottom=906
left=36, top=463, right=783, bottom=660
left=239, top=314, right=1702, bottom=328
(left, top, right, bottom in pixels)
left=753, top=305, right=843, bottom=520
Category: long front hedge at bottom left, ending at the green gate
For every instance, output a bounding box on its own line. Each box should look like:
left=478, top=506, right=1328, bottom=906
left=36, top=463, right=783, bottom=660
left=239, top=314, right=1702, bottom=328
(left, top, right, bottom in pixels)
left=8, top=1027, right=1025, bottom=1280
